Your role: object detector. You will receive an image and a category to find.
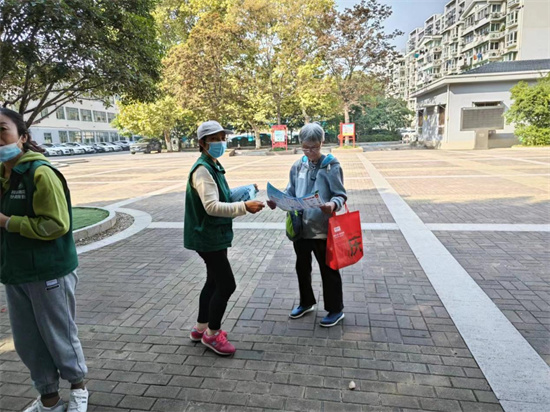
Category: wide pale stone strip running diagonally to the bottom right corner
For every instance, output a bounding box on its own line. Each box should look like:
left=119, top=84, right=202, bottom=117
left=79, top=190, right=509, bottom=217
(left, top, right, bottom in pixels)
left=357, top=154, right=550, bottom=412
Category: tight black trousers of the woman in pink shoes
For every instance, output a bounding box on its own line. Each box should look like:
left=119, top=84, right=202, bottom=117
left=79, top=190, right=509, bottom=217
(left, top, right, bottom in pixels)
left=197, top=249, right=237, bottom=330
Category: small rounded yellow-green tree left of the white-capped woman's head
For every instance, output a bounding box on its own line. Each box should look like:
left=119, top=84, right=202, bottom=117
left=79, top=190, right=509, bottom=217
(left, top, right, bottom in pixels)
left=114, top=96, right=192, bottom=148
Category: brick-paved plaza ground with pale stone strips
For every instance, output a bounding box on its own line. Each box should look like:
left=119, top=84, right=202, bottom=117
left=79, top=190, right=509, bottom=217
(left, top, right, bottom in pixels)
left=0, top=148, right=550, bottom=412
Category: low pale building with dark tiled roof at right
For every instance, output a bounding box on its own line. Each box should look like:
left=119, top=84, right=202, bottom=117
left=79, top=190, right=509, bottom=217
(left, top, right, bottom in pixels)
left=411, top=59, right=550, bottom=149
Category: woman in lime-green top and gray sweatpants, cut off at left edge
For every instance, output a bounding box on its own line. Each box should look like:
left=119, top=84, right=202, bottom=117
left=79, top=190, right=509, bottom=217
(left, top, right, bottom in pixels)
left=0, top=108, right=88, bottom=412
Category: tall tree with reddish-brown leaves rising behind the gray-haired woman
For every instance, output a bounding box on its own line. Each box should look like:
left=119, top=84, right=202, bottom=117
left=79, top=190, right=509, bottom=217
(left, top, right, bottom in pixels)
left=320, top=0, right=402, bottom=123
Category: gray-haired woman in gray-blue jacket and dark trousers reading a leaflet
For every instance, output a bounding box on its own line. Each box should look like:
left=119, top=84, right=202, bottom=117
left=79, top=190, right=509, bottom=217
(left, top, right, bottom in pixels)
left=267, top=123, right=347, bottom=327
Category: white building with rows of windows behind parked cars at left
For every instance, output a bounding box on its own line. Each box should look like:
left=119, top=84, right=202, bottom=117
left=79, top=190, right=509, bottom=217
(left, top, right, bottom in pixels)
left=30, top=99, right=125, bottom=144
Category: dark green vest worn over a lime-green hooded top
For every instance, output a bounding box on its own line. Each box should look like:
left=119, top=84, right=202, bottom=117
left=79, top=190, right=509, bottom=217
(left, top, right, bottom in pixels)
left=0, top=160, right=78, bottom=285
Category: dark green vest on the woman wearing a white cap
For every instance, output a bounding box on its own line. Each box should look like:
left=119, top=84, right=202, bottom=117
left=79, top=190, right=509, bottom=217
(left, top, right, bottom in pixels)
left=183, top=154, right=233, bottom=252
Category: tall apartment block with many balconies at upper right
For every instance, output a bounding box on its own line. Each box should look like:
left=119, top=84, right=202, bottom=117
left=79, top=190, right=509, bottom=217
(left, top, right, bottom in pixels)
left=388, top=0, right=550, bottom=110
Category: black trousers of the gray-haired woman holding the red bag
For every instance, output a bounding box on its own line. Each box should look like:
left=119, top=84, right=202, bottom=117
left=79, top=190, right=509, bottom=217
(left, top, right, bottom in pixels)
left=294, top=239, right=344, bottom=313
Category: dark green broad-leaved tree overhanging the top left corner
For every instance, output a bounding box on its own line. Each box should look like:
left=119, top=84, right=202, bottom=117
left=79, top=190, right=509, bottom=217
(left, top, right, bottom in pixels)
left=0, top=0, right=162, bottom=126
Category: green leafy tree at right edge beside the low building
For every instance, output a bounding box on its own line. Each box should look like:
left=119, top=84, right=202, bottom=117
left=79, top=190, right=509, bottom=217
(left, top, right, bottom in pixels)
left=505, top=74, right=550, bottom=146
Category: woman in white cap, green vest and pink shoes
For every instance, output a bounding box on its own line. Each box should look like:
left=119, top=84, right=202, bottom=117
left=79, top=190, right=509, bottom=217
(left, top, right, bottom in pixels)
left=183, top=120, right=264, bottom=355
